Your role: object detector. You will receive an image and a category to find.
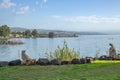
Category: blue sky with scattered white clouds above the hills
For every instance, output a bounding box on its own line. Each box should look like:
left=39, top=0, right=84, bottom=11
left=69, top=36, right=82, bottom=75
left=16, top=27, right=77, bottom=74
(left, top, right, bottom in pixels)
left=0, top=0, right=120, bottom=31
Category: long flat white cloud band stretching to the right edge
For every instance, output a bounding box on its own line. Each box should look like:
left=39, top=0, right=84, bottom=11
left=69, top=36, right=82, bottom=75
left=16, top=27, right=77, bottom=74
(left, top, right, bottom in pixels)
left=51, top=16, right=120, bottom=23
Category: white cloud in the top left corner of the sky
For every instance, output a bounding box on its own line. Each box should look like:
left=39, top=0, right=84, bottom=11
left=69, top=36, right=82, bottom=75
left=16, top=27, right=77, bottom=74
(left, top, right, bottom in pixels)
left=0, top=0, right=16, bottom=9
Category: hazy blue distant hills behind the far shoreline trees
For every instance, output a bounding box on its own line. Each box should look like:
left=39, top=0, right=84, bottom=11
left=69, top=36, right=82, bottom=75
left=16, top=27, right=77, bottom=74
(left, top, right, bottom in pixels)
left=10, top=27, right=107, bottom=35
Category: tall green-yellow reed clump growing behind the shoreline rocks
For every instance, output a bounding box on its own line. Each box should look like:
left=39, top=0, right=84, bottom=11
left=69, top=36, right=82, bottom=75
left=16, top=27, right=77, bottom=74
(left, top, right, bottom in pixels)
left=50, top=41, right=80, bottom=61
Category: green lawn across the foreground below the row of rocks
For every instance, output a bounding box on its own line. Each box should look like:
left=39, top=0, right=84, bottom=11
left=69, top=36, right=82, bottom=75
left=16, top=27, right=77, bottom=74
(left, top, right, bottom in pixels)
left=0, top=63, right=120, bottom=80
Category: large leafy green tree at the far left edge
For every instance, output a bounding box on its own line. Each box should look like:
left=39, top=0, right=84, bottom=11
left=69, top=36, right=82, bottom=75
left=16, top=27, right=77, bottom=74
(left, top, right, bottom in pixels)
left=0, top=25, right=10, bottom=37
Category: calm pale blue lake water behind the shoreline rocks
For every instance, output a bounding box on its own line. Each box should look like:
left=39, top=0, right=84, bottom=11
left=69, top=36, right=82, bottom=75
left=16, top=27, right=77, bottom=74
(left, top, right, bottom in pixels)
left=0, top=35, right=120, bottom=61
